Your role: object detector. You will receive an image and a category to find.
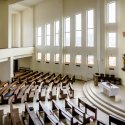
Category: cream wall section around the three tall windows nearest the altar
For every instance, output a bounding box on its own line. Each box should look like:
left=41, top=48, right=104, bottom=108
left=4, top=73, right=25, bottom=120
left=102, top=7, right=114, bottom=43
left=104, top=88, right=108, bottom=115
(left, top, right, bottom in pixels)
left=63, top=0, right=98, bottom=79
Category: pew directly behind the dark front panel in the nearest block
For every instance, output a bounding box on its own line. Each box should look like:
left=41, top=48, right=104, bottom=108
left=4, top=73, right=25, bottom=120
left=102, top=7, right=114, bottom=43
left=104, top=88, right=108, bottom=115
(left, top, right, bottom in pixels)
left=65, top=99, right=90, bottom=124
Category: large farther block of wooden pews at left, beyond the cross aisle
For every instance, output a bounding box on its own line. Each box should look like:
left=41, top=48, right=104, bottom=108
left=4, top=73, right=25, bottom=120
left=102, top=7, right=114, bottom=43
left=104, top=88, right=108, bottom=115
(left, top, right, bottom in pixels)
left=0, top=71, right=75, bottom=104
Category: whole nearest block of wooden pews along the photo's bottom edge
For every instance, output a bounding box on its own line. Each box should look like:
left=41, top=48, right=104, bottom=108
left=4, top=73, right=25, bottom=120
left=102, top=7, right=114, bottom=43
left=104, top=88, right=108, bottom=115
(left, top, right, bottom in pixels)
left=0, top=98, right=125, bottom=125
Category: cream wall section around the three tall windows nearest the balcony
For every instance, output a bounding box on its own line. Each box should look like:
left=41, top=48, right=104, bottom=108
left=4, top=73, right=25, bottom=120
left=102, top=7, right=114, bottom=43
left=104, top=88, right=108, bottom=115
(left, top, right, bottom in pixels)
left=34, top=0, right=63, bottom=73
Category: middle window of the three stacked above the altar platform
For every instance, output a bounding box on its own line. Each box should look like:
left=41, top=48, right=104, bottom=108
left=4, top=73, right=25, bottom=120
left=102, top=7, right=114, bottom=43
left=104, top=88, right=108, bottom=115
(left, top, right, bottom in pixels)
left=108, top=33, right=116, bottom=47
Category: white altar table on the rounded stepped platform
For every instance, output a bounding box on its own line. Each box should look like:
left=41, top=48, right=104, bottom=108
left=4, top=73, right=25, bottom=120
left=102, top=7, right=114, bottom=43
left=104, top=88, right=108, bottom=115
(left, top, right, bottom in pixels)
left=99, top=82, right=120, bottom=96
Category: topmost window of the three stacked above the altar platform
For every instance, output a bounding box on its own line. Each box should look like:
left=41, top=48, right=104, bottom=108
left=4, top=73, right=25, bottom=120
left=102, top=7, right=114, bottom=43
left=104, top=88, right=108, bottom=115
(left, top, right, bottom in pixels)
left=108, top=2, right=116, bottom=23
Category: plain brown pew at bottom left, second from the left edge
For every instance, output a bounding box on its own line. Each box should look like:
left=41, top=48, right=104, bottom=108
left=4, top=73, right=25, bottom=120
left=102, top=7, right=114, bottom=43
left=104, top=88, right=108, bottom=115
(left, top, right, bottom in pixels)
left=10, top=103, right=23, bottom=125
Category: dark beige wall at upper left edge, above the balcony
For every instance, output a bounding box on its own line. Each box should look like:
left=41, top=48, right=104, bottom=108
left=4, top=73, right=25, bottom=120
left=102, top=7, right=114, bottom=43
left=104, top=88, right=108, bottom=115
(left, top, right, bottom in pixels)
left=0, top=0, right=8, bottom=48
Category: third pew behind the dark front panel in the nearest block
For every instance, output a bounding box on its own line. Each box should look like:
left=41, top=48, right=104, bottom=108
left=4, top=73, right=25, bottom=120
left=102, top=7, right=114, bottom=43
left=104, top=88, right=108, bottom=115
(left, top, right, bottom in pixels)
left=39, top=101, right=62, bottom=125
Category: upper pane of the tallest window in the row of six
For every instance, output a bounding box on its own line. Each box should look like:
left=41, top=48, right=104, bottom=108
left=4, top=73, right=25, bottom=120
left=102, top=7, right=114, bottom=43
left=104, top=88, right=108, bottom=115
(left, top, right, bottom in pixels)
left=87, top=10, right=94, bottom=28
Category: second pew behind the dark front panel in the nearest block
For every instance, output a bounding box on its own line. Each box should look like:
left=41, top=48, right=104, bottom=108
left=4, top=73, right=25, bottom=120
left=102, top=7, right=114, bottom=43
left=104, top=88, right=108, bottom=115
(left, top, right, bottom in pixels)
left=52, top=100, right=78, bottom=125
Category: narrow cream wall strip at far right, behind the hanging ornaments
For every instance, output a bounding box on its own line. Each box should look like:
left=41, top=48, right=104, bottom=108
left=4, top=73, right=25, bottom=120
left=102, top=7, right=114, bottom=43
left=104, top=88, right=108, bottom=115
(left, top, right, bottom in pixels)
left=117, top=0, right=125, bottom=85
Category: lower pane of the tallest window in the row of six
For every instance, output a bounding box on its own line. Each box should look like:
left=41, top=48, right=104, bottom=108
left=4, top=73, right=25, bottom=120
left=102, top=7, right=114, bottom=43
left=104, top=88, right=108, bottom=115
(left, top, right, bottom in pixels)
left=87, top=29, right=94, bottom=47
